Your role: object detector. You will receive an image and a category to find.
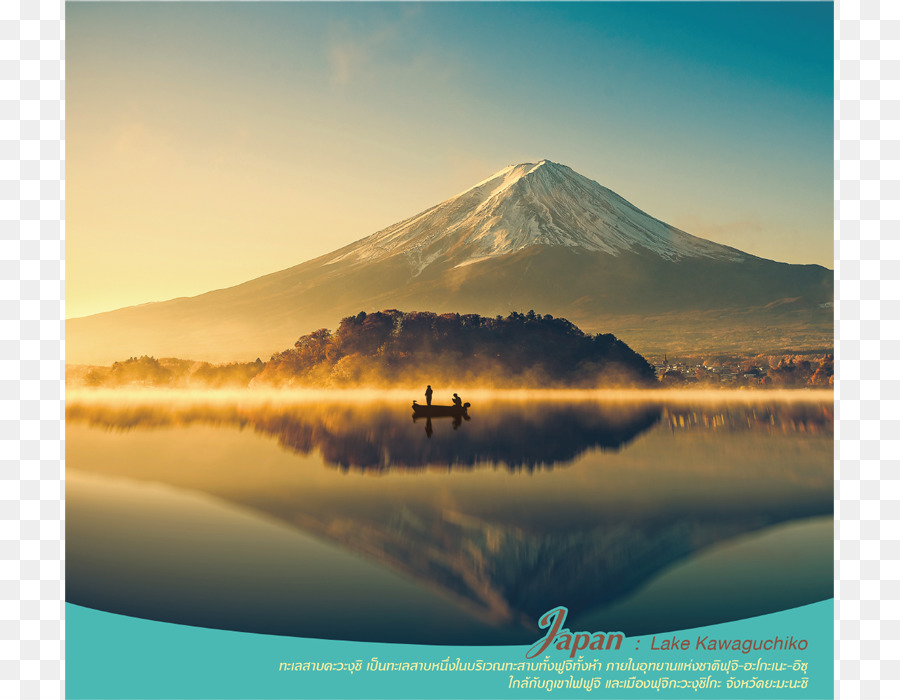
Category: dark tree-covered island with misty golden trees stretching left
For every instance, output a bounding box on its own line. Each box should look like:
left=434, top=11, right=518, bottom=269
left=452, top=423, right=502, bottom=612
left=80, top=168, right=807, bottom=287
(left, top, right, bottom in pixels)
left=68, top=309, right=656, bottom=388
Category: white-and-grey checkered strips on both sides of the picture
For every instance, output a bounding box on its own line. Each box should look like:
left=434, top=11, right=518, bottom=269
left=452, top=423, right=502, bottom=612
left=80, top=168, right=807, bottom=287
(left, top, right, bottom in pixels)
left=0, top=0, right=884, bottom=700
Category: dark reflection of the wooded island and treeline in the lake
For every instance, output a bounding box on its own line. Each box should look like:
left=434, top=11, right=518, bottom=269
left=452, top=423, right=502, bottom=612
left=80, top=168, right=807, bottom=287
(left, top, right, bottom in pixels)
left=66, top=403, right=662, bottom=472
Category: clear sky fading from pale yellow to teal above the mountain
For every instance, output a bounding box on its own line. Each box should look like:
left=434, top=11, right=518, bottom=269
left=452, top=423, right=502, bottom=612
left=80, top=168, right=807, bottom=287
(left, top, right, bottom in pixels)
left=66, top=2, right=834, bottom=318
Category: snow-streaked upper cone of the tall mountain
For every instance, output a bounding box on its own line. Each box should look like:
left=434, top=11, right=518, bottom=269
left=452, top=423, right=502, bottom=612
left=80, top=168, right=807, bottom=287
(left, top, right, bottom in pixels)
left=329, top=160, right=747, bottom=273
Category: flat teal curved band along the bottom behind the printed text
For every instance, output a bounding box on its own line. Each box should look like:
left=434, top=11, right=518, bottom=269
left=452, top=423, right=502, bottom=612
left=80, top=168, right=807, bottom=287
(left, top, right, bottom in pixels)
left=66, top=599, right=834, bottom=700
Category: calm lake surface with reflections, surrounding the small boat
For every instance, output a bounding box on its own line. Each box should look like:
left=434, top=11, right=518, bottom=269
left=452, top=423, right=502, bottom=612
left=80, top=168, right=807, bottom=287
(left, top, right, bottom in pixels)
left=66, top=394, right=833, bottom=644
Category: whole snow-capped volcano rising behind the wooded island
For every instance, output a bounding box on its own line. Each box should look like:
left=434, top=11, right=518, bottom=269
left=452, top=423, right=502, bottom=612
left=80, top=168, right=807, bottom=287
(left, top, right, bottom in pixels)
left=66, top=160, right=834, bottom=363
